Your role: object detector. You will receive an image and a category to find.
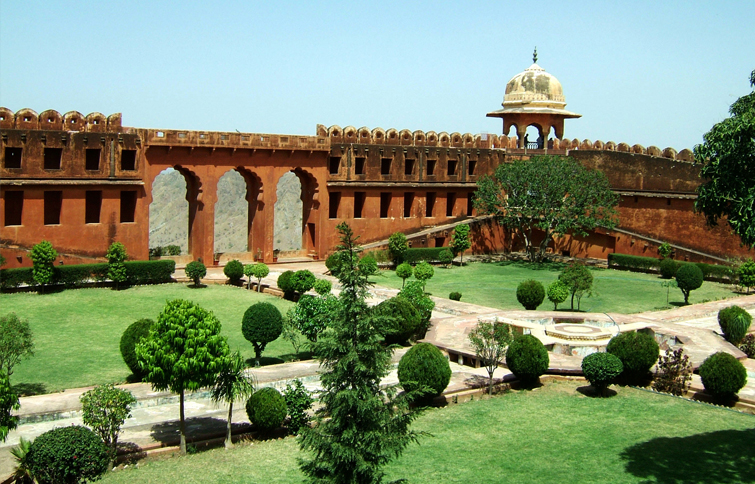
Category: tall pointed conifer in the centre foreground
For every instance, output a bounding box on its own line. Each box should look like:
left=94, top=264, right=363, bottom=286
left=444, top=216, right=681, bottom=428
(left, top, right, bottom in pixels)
left=299, top=223, right=418, bottom=484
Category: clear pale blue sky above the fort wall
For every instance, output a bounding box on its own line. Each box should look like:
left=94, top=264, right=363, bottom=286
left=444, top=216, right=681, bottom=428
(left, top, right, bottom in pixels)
left=0, top=0, right=755, bottom=150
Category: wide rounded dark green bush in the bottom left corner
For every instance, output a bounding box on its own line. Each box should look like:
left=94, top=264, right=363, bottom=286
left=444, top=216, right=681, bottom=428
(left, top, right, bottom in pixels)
left=24, top=425, right=109, bottom=483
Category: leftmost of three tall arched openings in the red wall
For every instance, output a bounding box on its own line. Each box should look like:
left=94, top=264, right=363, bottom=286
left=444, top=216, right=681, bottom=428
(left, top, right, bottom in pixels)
left=149, top=168, right=190, bottom=255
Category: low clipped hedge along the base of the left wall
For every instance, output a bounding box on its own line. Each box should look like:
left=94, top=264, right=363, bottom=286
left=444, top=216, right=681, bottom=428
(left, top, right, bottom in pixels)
left=0, top=260, right=176, bottom=289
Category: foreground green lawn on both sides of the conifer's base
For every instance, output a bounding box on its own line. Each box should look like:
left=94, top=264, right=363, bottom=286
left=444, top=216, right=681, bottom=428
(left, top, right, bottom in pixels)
left=102, top=382, right=755, bottom=484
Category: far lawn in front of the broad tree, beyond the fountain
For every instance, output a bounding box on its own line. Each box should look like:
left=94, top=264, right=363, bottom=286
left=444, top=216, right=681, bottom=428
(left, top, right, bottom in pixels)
left=372, top=262, right=735, bottom=314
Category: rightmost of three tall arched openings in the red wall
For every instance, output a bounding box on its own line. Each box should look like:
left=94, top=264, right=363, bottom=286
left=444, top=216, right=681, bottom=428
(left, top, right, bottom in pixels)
left=273, top=171, right=304, bottom=252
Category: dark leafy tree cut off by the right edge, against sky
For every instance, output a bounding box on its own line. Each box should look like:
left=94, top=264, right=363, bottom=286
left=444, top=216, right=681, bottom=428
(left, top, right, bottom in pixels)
left=695, top=71, right=755, bottom=247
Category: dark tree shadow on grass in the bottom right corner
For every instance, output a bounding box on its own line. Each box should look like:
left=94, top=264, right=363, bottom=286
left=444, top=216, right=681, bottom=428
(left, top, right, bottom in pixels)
left=620, top=428, right=755, bottom=484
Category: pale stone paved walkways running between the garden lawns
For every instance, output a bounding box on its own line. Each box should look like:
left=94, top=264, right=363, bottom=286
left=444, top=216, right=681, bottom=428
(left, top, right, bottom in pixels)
left=0, top=261, right=755, bottom=479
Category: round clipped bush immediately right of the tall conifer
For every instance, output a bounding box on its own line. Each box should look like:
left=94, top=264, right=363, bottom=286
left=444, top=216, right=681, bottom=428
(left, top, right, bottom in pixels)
left=398, top=343, right=451, bottom=398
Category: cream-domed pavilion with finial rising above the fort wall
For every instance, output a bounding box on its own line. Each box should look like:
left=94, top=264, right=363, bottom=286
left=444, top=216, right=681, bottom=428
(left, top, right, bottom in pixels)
left=487, top=49, right=582, bottom=149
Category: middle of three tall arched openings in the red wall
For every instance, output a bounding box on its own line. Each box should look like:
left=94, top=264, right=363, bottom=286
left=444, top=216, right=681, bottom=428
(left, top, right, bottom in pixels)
left=214, top=170, right=249, bottom=253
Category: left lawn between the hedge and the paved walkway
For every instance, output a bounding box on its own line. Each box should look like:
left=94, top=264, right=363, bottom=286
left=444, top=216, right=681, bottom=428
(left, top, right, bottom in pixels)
left=0, top=284, right=293, bottom=393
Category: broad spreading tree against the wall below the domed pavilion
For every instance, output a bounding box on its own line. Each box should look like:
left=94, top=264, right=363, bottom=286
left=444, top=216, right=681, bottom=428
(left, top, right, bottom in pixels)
left=475, top=156, right=619, bottom=261
